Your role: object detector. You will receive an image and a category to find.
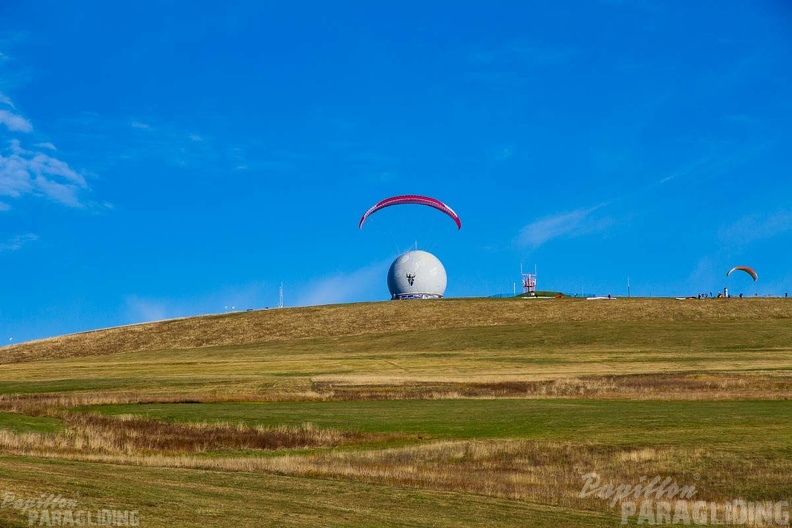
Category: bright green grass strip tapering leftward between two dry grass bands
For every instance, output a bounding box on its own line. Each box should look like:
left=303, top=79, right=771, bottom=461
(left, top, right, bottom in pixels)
left=96, top=399, right=792, bottom=453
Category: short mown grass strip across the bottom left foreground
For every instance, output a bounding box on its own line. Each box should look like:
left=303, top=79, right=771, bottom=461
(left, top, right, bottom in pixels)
left=0, top=457, right=618, bottom=528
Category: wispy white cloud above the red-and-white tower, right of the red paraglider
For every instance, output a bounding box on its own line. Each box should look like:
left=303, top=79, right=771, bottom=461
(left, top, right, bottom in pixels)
left=517, top=204, right=613, bottom=248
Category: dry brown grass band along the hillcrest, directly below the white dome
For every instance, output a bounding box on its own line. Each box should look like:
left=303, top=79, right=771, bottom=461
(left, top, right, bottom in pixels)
left=0, top=299, right=792, bottom=363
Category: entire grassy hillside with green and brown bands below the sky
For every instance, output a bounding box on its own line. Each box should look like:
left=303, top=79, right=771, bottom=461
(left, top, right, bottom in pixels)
left=0, top=299, right=792, bottom=527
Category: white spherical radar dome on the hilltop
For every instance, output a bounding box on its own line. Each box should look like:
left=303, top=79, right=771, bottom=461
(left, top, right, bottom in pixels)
left=388, top=249, right=448, bottom=299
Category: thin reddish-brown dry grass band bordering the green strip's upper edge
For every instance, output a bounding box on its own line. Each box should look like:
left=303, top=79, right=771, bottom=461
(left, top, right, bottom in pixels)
left=0, top=371, right=792, bottom=417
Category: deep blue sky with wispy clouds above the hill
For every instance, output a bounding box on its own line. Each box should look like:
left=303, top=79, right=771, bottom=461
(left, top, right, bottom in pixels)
left=0, top=0, right=792, bottom=343
